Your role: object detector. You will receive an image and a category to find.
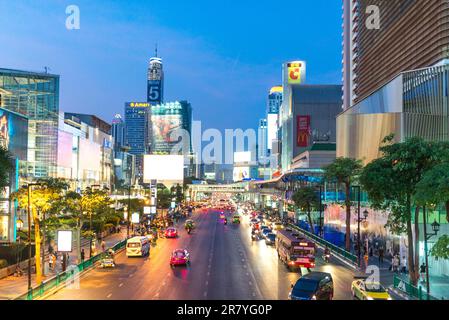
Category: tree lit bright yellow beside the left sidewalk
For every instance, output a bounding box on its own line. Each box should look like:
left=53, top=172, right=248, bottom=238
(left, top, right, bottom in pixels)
left=11, top=179, right=67, bottom=284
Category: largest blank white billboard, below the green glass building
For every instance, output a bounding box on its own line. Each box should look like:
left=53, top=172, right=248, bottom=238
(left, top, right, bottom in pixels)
left=143, top=155, right=184, bottom=183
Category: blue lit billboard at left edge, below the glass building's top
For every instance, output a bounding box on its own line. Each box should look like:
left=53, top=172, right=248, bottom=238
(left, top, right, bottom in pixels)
left=0, top=108, right=28, bottom=160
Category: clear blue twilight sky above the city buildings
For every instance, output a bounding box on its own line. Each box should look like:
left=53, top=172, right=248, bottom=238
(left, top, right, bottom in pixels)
left=0, top=0, right=342, bottom=129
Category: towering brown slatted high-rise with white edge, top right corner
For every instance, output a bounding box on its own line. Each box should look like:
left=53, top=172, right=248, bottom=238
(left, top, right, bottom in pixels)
left=343, top=0, right=449, bottom=109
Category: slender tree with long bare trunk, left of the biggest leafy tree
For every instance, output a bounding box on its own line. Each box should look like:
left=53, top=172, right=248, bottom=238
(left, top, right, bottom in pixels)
left=324, top=158, right=362, bottom=251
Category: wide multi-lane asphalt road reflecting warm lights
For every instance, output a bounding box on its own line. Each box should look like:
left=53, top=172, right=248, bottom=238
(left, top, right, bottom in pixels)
left=48, top=210, right=353, bottom=300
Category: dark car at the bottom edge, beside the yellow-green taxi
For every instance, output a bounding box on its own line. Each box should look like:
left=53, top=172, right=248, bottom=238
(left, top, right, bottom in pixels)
left=289, top=272, right=334, bottom=300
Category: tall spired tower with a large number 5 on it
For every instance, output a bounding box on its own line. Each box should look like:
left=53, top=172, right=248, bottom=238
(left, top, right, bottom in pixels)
left=147, top=49, right=164, bottom=104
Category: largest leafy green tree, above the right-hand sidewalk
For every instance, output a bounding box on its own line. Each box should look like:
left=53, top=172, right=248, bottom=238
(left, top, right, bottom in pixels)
left=360, top=135, right=447, bottom=285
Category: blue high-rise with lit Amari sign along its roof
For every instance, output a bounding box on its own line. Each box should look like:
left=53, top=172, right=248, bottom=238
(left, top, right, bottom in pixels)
left=125, top=102, right=151, bottom=182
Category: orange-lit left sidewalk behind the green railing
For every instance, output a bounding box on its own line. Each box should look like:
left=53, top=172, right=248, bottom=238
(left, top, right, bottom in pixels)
left=0, top=228, right=126, bottom=300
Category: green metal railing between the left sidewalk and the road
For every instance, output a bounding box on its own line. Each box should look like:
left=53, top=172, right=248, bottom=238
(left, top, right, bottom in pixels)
left=14, top=239, right=127, bottom=300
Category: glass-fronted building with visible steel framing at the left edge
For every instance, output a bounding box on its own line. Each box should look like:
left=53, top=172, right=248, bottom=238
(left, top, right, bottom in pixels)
left=0, top=69, right=59, bottom=180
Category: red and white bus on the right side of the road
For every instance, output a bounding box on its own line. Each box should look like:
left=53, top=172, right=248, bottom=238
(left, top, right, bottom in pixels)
left=275, top=229, right=316, bottom=270
